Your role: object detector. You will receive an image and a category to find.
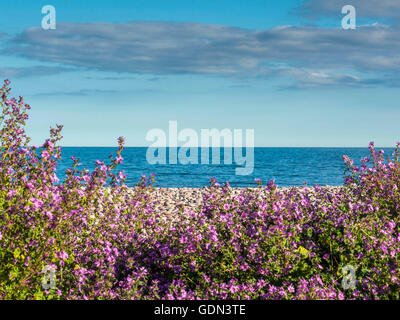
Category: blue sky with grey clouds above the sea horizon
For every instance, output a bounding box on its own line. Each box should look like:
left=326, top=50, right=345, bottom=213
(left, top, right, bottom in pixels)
left=0, top=0, right=400, bottom=147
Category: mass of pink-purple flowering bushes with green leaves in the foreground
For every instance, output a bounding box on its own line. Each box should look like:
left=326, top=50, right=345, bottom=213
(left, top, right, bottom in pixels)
left=0, top=81, right=400, bottom=299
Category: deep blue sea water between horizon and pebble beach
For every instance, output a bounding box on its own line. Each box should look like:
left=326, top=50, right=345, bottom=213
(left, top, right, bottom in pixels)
left=57, top=147, right=394, bottom=188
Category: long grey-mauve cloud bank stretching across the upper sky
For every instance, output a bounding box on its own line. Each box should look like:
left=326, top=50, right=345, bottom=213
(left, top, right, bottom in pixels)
left=3, top=21, right=400, bottom=88
